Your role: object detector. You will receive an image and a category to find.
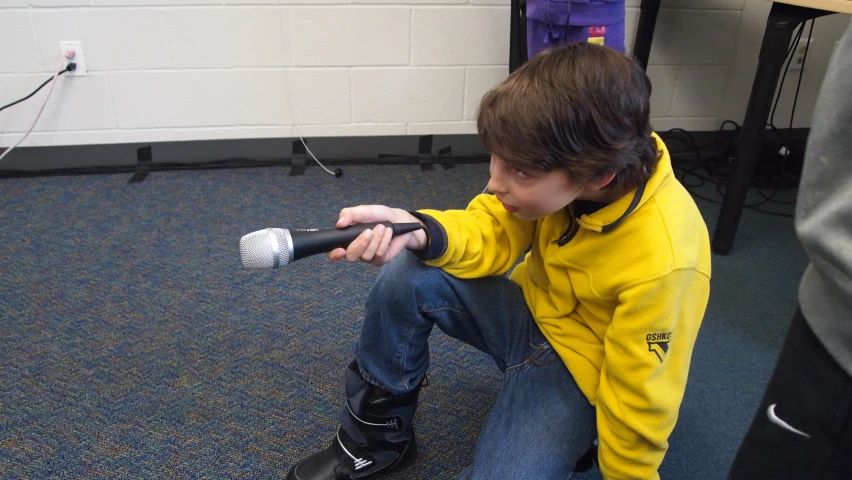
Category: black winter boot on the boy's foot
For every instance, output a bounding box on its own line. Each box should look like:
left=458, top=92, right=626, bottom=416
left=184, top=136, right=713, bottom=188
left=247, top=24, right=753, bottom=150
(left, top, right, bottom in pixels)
left=287, top=361, right=420, bottom=480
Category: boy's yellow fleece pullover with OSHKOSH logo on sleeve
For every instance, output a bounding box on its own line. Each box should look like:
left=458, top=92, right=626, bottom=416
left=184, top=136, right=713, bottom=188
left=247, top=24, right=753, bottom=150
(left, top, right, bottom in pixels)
left=419, top=135, right=710, bottom=480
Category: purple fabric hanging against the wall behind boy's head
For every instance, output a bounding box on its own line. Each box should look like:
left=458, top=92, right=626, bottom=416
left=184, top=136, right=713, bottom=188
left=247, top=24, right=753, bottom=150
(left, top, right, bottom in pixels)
left=526, top=0, right=625, bottom=58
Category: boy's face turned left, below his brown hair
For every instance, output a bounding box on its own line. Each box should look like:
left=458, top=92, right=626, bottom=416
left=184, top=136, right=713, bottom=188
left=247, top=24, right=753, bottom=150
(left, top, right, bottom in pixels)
left=488, top=155, right=583, bottom=220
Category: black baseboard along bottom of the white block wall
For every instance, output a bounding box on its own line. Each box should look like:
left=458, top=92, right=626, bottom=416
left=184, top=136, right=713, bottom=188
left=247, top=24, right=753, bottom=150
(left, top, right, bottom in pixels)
left=0, top=129, right=808, bottom=181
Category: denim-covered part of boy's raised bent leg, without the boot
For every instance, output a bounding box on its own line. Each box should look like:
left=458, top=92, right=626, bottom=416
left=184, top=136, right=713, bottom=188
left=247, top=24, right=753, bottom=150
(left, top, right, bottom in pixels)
left=355, top=254, right=544, bottom=395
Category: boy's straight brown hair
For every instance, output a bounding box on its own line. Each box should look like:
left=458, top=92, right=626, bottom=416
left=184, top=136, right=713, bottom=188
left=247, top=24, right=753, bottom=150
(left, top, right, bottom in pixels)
left=476, top=43, right=660, bottom=188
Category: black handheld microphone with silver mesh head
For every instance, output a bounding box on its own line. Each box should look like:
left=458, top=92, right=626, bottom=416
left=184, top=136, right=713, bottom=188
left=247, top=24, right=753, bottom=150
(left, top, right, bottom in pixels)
left=240, top=222, right=423, bottom=268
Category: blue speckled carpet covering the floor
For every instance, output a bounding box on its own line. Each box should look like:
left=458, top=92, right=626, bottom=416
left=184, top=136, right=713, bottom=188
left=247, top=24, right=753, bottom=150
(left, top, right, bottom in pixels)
left=0, top=164, right=805, bottom=480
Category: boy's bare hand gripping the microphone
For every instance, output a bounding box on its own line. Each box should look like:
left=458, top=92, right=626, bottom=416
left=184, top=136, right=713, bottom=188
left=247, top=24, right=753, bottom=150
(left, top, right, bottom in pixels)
left=328, top=205, right=427, bottom=266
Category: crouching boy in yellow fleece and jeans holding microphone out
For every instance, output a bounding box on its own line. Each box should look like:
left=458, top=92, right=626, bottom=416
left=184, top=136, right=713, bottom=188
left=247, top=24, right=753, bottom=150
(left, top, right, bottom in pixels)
left=287, top=44, right=710, bottom=480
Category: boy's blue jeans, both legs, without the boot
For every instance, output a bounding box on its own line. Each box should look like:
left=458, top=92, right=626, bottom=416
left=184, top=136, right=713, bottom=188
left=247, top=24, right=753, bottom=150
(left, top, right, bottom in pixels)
left=355, top=252, right=597, bottom=480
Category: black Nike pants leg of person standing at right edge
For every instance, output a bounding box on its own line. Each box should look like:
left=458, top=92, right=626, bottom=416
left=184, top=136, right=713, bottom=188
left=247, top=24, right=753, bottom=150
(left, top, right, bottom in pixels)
left=728, top=311, right=852, bottom=480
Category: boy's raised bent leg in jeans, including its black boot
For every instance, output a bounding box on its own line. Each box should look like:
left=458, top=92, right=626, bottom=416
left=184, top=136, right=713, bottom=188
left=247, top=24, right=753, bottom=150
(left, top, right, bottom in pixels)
left=288, top=252, right=541, bottom=480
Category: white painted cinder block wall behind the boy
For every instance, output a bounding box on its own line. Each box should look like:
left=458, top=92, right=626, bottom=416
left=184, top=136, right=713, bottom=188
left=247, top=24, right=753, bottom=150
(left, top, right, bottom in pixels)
left=0, top=0, right=848, bottom=146
